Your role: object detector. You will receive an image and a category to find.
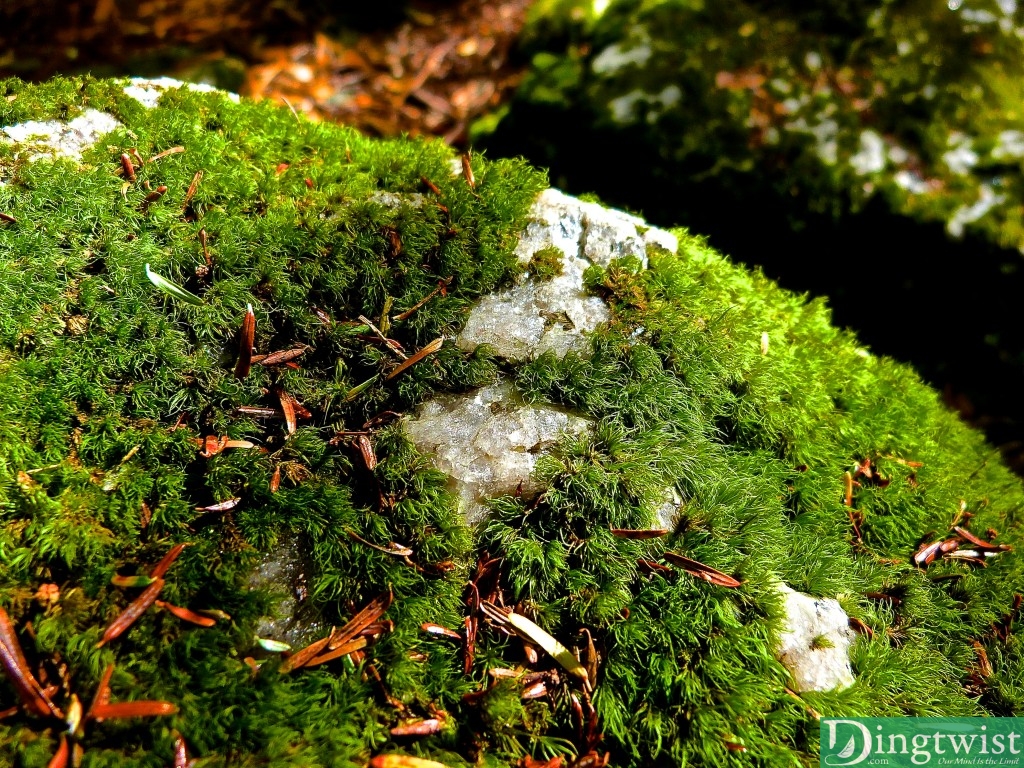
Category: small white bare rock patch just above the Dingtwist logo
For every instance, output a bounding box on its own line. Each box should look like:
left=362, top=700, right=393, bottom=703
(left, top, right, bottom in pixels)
left=775, top=584, right=856, bottom=691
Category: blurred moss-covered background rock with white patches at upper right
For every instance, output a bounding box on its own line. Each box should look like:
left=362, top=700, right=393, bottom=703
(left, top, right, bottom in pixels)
left=483, top=0, right=1024, bottom=249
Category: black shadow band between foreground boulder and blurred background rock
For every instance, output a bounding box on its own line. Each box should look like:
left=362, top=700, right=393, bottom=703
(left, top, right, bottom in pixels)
left=486, top=105, right=1024, bottom=472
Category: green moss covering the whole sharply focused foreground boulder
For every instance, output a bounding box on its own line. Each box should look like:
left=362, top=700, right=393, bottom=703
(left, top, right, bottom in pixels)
left=0, top=80, right=1024, bottom=766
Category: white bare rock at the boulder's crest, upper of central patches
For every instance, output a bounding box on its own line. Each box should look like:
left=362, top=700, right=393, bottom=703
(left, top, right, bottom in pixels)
left=457, top=189, right=679, bottom=361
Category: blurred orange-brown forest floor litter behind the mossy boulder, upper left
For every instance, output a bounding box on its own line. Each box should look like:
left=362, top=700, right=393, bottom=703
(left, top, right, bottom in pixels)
left=0, top=0, right=1024, bottom=474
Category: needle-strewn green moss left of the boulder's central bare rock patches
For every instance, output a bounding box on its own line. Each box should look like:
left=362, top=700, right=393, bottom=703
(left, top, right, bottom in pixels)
left=0, top=73, right=546, bottom=766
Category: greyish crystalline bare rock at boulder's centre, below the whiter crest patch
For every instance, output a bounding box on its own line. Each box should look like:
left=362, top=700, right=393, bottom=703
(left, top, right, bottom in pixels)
left=404, top=382, right=592, bottom=524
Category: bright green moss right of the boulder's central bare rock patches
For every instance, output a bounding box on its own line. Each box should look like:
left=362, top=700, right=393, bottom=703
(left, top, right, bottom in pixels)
left=483, top=239, right=1024, bottom=766
